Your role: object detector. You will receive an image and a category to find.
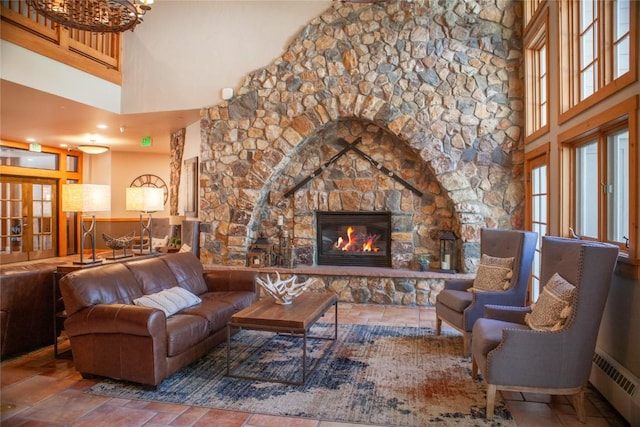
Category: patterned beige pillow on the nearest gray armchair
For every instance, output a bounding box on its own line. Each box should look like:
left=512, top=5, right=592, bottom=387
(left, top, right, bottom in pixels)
left=524, top=273, right=576, bottom=331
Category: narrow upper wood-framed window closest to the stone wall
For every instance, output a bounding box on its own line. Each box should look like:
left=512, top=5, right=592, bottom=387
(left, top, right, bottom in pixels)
left=525, top=12, right=549, bottom=140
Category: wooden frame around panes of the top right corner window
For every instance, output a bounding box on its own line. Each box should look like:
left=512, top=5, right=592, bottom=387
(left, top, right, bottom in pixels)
left=557, top=0, right=640, bottom=123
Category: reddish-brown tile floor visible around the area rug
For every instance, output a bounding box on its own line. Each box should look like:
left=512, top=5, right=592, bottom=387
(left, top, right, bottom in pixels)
left=0, top=304, right=628, bottom=427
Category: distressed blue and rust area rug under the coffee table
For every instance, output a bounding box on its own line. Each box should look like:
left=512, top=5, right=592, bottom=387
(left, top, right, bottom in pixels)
left=87, top=324, right=515, bottom=427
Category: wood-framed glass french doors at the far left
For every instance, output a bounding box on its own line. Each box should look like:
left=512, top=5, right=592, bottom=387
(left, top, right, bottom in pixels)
left=0, top=176, right=57, bottom=264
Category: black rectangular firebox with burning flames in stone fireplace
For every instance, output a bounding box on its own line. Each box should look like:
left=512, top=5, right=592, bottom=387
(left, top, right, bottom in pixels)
left=316, top=211, right=391, bottom=267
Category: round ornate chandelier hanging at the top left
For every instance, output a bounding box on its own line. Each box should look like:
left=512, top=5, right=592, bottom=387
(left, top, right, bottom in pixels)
left=27, top=0, right=153, bottom=33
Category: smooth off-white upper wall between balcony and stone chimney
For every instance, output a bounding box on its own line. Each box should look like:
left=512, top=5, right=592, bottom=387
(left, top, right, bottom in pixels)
left=122, top=0, right=331, bottom=113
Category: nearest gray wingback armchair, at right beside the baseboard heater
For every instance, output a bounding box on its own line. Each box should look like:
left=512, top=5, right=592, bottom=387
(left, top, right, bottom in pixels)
left=471, top=237, right=618, bottom=422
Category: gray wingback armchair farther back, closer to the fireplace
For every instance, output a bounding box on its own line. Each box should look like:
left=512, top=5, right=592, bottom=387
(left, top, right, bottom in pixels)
left=436, top=228, right=538, bottom=356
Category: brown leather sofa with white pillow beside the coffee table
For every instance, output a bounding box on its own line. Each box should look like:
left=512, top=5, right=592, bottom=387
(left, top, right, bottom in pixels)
left=60, top=252, right=259, bottom=388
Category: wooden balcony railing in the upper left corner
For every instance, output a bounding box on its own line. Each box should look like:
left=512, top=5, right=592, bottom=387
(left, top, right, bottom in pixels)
left=0, top=0, right=122, bottom=85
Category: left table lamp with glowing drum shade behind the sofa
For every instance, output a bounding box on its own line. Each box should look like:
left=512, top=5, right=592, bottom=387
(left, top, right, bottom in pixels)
left=62, top=184, right=111, bottom=264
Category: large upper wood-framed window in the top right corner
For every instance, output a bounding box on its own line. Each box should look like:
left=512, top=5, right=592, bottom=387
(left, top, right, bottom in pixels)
left=559, top=0, right=638, bottom=120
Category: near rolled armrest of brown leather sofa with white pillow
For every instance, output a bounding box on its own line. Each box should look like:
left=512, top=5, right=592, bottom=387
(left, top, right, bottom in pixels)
left=64, top=304, right=167, bottom=337
